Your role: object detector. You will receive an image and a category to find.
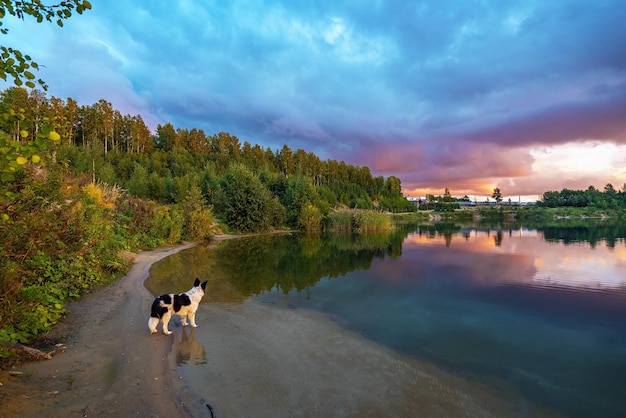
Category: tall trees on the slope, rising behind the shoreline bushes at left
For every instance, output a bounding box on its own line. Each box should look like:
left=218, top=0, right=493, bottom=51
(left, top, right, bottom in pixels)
left=0, top=87, right=414, bottom=232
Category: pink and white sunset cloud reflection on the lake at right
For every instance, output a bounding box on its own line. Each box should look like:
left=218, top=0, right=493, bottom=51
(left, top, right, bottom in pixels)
left=400, top=230, right=626, bottom=289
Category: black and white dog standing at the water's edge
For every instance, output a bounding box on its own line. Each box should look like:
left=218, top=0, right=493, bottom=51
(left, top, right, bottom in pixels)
left=148, top=279, right=207, bottom=335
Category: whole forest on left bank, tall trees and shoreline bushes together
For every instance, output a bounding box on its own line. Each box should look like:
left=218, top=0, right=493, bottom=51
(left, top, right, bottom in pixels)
left=0, top=87, right=416, bottom=354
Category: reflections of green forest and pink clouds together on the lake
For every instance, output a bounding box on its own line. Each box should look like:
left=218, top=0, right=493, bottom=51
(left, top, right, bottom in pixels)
left=146, top=223, right=626, bottom=303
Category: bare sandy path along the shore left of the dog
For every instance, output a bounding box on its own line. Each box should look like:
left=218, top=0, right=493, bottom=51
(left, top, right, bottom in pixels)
left=0, top=244, right=199, bottom=418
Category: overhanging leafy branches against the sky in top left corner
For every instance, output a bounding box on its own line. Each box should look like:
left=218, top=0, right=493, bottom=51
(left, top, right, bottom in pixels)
left=0, top=0, right=91, bottom=90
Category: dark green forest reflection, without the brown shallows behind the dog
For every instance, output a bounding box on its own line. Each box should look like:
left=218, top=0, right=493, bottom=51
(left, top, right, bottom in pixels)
left=213, top=231, right=405, bottom=295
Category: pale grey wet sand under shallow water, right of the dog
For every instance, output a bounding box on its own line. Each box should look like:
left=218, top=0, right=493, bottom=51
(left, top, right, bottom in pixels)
left=174, top=300, right=557, bottom=418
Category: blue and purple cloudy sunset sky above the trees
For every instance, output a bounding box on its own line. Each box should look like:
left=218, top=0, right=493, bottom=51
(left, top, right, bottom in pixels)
left=0, top=0, right=626, bottom=201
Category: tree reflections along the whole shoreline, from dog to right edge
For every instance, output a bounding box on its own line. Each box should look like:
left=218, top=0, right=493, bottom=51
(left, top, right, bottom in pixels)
left=146, top=222, right=626, bottom=302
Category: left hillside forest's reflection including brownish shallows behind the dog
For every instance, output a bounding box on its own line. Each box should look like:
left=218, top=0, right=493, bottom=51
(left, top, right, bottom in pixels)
left=146, top=231, right=405, bottom=303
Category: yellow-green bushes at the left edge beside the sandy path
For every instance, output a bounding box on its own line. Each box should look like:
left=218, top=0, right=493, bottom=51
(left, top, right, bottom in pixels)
left=0, top=178, right=128, bottom=354
